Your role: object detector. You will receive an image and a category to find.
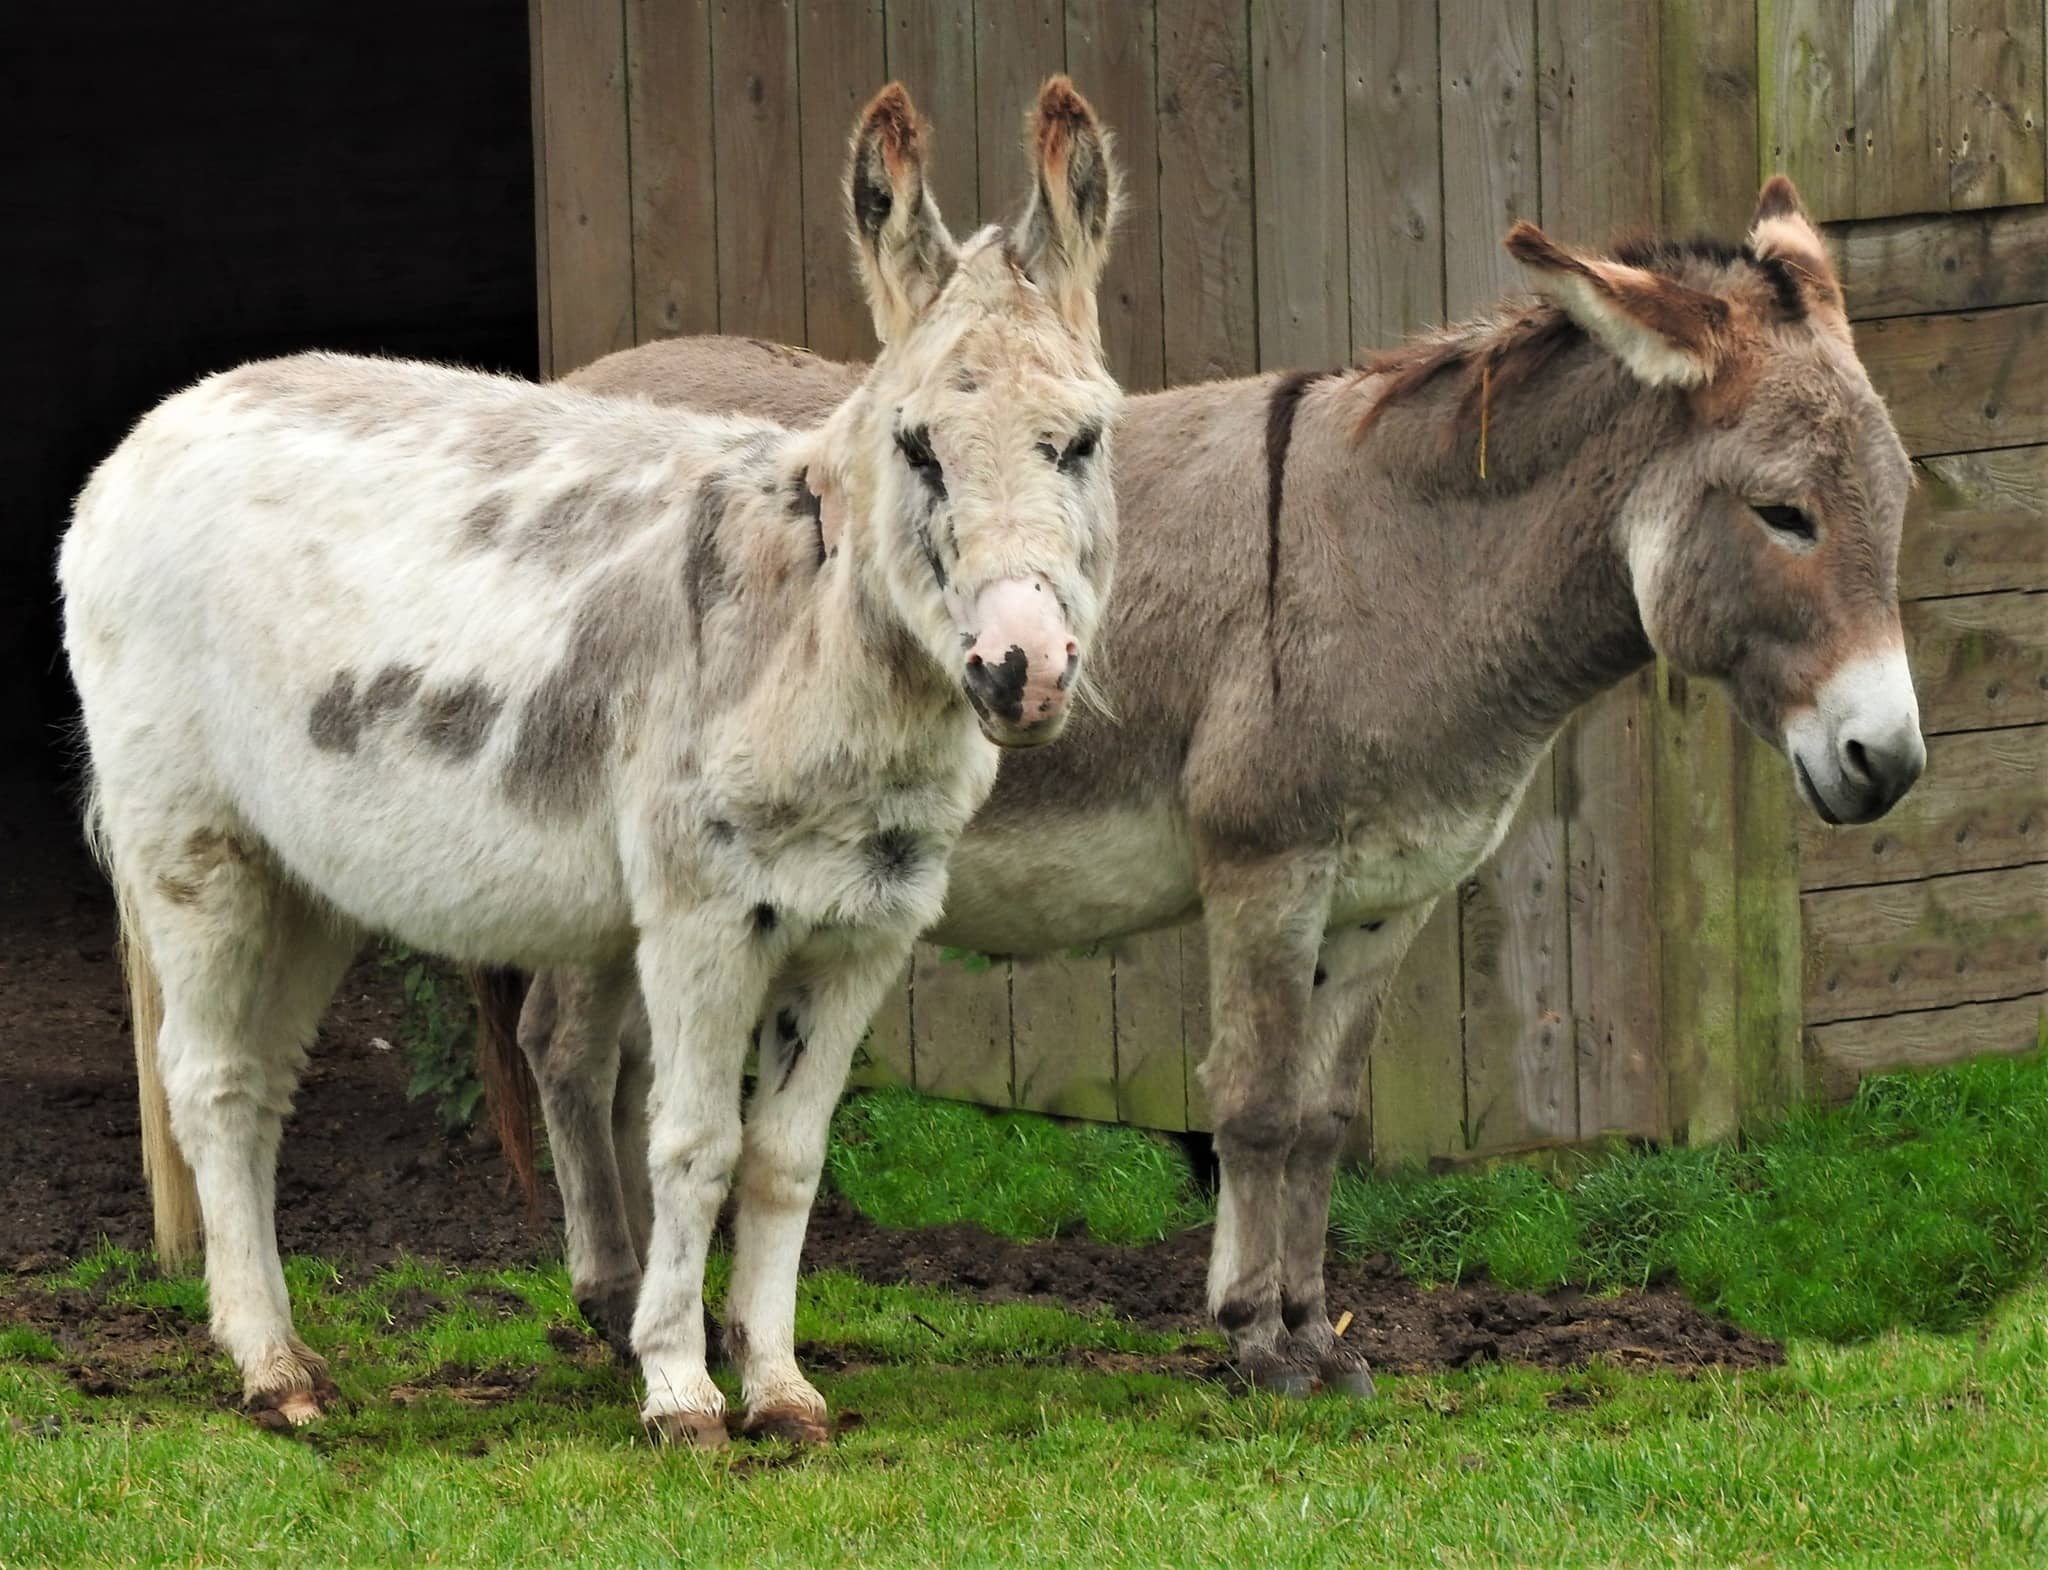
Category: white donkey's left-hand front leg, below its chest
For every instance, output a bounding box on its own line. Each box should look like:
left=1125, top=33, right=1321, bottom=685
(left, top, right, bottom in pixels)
left=633, top=907, right=780, bottom=1449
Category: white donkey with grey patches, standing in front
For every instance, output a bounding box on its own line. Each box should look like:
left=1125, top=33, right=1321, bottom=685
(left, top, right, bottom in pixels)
left=59, top=78, right=1118, bottom=1445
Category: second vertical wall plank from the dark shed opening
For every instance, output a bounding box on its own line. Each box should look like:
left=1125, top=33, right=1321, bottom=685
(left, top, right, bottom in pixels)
left=627, top=0, right=719, bottom=344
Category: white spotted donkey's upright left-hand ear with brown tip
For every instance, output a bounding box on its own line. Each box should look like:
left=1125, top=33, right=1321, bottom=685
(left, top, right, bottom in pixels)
left=846, top=82, right=958, bottom=344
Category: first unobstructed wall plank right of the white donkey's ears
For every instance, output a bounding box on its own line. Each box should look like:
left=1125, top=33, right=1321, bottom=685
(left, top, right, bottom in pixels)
left=1159, top=0, right=1257, bottom=380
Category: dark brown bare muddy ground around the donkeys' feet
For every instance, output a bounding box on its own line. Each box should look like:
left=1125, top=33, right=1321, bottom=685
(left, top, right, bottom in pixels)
left=0, top=780, right=1780, bottom=1369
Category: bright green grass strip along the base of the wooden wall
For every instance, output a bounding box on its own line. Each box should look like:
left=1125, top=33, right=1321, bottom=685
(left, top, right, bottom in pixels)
left=829, top=1052, right=2048, bottom=1341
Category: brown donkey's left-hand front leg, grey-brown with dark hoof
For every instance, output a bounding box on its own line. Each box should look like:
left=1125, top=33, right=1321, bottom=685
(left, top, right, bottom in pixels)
left=1200, top=856, right=1329, bottom=1396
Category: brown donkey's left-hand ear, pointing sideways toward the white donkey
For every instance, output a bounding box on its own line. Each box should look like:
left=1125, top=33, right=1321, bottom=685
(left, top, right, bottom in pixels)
left=1507, top=221, right=1731, bottom=387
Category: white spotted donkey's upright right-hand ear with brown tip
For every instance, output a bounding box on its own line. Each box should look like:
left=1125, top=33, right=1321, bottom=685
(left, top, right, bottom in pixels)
left=1016, top=76, right=1124, bottom=338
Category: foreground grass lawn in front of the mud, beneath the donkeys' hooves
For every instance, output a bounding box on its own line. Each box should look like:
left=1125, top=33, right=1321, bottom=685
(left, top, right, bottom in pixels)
left=0, top=1253, right=2048, bottom=1570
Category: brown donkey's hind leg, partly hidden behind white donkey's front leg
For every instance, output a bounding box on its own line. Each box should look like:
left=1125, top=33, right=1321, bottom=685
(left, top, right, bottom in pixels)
left=518, top=960, right=645, bottom=1357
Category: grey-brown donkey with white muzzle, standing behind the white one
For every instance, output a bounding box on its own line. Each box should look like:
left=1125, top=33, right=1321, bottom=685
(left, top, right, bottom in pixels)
left=495, top=178, right=1925, bottom=1394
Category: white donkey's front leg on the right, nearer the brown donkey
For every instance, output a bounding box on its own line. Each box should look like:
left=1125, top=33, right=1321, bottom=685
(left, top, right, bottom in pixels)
left=725, top=935, right=909, bottom=1443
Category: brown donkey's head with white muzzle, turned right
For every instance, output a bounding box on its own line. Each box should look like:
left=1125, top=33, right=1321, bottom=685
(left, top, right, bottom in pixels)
left=1507, top=176, right=1927, bottom=823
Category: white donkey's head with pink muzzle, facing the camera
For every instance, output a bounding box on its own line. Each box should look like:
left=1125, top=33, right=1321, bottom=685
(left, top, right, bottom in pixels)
left=821, top=76, right=1122, bottom=747
